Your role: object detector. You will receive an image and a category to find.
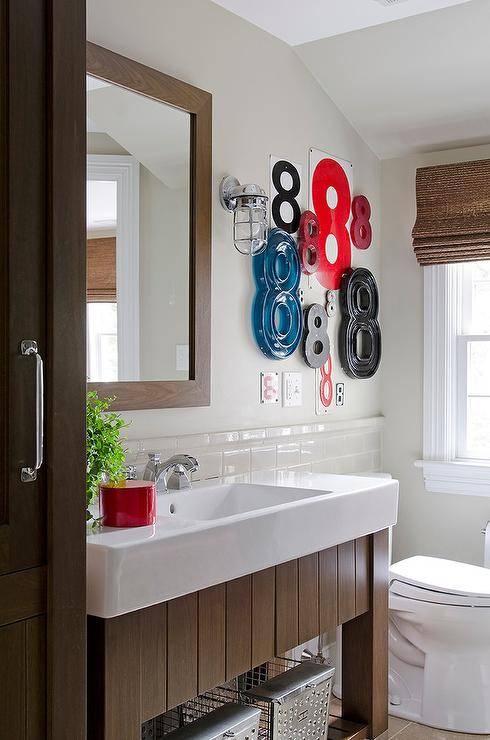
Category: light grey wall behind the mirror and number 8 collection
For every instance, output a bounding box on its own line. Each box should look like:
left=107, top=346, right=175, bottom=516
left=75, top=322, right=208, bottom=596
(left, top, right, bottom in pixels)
left=87, top=0, right=380, bottom=438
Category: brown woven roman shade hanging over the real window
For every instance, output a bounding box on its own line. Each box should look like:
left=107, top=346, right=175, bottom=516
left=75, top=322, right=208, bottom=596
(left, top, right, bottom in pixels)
left=412, top=159, right=490, bottom=265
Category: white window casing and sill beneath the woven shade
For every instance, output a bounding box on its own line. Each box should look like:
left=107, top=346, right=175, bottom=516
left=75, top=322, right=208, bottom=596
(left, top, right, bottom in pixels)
left=416, top=265, right=490, bottom=496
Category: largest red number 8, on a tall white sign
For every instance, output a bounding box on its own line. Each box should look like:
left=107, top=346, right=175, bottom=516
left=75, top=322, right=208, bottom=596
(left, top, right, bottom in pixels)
left=312, top=159, right=351, bottom=290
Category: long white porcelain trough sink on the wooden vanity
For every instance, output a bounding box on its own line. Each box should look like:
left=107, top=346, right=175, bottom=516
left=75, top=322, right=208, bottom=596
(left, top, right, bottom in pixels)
left=87, top=472, right=398, bottom=618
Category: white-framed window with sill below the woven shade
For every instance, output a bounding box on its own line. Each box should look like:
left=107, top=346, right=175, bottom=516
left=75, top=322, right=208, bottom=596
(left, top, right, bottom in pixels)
left=419, top=261, right=490, bottom=496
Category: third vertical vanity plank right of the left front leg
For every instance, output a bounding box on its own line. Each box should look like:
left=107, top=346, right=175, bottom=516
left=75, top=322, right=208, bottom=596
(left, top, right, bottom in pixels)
left=199, top=583, right=226, bottom=692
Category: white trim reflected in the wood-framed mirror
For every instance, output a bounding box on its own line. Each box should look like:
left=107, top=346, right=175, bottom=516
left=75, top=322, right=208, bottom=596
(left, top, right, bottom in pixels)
left=87, top=154, right=140, bottom=380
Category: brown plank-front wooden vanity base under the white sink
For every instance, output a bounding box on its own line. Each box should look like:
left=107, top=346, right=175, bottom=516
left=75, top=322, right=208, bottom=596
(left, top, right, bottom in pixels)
left=88, top=530, right=388, bottom=740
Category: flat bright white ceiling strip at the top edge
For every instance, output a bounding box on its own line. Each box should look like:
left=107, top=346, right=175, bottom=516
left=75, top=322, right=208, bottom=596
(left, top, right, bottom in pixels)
left=213, top=0, right=469, bottom=46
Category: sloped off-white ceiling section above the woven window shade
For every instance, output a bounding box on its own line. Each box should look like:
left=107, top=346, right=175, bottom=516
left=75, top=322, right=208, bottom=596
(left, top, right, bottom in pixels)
left=296, top=0, right=490, bottom=158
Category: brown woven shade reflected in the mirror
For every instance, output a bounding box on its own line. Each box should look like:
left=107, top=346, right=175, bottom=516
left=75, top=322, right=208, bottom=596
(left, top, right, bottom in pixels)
left=87, top=236, right=116, bottom=303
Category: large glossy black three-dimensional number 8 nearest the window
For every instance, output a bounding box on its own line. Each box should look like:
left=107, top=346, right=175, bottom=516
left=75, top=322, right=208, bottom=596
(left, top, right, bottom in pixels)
left=339, top=267, right=381, bottom=378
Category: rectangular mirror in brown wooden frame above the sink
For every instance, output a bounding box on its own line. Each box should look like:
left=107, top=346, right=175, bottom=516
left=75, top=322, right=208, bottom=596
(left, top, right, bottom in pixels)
left=87, top=43, right=212, bottom=410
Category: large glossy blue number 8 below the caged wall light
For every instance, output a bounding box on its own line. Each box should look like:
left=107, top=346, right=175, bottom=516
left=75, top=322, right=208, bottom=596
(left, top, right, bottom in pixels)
left=252, top=229, right=303, bottom=360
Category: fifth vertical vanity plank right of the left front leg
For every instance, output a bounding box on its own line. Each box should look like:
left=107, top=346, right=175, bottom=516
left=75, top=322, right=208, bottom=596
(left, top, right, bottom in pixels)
left=252, top=568, right=276, bottom=666
